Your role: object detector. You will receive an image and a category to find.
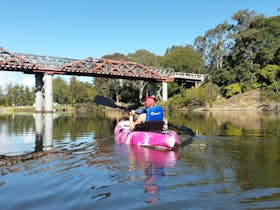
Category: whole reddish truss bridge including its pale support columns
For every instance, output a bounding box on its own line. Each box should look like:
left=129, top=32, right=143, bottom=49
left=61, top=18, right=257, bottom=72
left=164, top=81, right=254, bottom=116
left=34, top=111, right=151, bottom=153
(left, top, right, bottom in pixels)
left=0, top=47, right=206, bottom=112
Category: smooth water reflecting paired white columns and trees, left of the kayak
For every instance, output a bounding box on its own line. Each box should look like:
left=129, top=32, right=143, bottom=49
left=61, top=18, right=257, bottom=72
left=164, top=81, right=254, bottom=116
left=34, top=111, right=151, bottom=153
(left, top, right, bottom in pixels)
left=0, top=113, right=114, bottom=156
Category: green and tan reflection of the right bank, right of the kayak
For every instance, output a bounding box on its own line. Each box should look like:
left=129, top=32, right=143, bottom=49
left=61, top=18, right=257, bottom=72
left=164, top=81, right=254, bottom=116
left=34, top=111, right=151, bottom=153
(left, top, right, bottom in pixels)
left=167, top=111, right=280, bottom=139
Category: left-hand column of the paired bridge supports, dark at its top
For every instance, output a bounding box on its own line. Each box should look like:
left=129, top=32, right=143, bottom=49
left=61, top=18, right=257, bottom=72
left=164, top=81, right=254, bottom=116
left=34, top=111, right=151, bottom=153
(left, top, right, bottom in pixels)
left=35, top=74, right=44, bottom=112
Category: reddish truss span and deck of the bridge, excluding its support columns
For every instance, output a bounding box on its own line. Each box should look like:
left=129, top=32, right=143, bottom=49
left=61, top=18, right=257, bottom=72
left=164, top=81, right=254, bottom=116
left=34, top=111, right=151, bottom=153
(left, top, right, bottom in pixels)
left=0, top=47, right=207, bottom=82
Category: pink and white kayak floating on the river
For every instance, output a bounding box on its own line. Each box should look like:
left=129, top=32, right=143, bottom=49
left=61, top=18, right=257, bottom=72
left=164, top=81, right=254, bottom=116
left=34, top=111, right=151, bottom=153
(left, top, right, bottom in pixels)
left=114, top=120, right=179, bottom=150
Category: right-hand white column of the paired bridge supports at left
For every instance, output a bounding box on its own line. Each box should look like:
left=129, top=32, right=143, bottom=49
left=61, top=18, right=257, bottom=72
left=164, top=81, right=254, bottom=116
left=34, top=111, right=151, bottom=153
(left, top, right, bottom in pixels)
left=44, top=74, right=53, bottom=112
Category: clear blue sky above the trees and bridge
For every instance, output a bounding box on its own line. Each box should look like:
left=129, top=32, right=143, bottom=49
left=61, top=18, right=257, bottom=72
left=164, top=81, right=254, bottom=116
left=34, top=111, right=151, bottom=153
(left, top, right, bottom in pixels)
left=0, top=0, right=280, bottom=89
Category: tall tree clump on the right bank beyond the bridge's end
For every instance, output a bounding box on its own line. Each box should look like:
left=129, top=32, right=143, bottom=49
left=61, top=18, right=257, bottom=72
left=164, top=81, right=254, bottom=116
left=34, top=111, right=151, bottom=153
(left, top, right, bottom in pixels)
left=194, top=10, right=280, bottom=97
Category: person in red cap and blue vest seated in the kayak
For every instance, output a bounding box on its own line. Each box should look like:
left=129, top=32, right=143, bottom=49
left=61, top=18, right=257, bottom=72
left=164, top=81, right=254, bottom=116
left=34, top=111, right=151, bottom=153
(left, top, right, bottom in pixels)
left=129, top=96, right=164, bottom=131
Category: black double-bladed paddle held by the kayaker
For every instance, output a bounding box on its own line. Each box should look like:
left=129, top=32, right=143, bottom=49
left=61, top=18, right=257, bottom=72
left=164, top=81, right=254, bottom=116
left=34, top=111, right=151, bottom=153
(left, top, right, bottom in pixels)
left=93, top=95, right=195, bottom=136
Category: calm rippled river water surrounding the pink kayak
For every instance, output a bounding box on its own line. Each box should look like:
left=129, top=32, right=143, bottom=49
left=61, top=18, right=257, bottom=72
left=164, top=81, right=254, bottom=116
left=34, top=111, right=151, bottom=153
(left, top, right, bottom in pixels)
left=0, top=112, right=280, bottom=210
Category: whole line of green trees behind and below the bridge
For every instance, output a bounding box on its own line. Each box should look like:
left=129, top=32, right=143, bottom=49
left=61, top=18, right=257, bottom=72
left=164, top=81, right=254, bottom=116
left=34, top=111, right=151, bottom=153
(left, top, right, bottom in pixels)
left=0, top=10, right=280, bottom=108
